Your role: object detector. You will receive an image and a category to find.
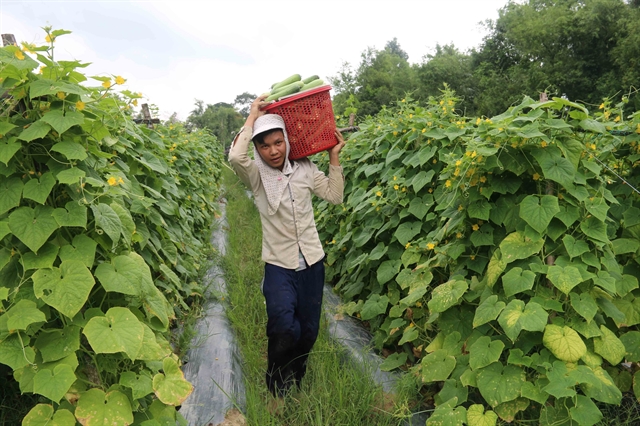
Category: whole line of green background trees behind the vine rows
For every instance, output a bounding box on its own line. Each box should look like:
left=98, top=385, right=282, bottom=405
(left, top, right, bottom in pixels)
left=187, top=0, right=640, bottom=145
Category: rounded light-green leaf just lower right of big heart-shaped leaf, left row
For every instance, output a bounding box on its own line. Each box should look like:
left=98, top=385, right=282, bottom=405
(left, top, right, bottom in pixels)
left=82, top=307, right=144, bottom=360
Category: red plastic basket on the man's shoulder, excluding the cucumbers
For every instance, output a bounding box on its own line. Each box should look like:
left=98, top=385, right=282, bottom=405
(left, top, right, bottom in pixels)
left=264, top=86, right=338, bottom=160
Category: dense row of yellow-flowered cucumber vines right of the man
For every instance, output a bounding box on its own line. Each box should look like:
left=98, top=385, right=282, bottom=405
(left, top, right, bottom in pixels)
left=316, top=90, right=640, bottom=425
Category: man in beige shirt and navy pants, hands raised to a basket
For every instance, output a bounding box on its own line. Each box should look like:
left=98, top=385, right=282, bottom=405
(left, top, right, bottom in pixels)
left=229, top=96, right=344, bottom=404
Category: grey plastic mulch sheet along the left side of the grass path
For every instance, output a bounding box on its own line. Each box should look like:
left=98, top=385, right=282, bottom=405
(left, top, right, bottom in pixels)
left=180, top=203, right=245, bottom=426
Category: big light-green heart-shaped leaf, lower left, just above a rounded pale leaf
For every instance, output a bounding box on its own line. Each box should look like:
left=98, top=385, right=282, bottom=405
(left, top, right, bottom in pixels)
left=32, top=260, right=95, bottom=318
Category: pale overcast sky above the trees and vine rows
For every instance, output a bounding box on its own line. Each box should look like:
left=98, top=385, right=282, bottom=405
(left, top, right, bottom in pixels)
left=0, top=0, right=507, bottom=119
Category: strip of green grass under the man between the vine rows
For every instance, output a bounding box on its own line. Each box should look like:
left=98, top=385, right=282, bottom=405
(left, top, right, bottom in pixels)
left=223, top=170, right=416, bottom=426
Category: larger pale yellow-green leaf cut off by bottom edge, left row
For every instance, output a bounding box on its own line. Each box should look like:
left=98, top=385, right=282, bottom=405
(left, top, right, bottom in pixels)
left=75, top=388, right=133, bottom=426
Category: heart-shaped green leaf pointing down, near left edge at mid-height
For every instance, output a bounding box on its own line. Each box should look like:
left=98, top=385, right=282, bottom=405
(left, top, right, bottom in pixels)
left=9, top=206, right=58, bottom=253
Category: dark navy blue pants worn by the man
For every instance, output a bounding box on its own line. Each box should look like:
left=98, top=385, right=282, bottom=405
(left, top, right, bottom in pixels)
left=262, top=260, right=324, bottom=396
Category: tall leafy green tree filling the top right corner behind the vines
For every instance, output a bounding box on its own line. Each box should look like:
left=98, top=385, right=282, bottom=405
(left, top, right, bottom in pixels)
left=472, top=0, right=638, bottom=115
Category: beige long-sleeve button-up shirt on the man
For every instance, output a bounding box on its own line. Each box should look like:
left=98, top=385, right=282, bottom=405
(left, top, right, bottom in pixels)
left=229, top=126, right=344, bottom=269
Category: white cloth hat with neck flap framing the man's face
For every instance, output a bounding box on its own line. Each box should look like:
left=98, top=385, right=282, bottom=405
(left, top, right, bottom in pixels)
left=252, top=114, right=293, bottom=215
